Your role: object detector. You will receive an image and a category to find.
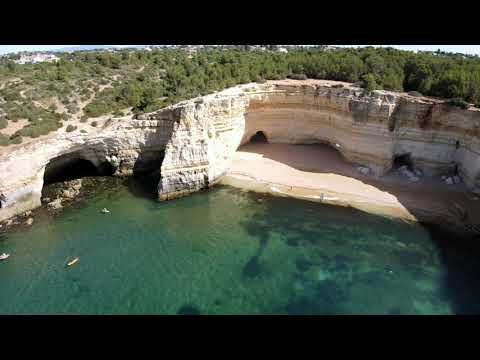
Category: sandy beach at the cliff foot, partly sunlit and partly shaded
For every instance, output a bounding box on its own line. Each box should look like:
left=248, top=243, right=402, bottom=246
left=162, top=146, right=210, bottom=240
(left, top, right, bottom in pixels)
left=222, top=143, right=480, bottom=231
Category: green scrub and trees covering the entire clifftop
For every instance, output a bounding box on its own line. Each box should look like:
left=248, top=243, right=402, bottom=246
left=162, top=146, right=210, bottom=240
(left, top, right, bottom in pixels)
left=0, top=46, right=480, bottom=142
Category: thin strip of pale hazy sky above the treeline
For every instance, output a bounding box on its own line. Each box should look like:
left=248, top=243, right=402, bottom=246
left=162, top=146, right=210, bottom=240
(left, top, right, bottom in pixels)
left=0, top=45, right=480, bottom=55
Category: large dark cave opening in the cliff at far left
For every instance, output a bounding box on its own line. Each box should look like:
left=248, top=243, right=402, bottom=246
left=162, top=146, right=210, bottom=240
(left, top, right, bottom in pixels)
left=43, top=154, right=114, bottom=185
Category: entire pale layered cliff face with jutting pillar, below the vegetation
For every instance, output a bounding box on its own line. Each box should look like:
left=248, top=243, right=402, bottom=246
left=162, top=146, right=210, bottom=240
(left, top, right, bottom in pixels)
left=0, top=81, right=480, bottom=221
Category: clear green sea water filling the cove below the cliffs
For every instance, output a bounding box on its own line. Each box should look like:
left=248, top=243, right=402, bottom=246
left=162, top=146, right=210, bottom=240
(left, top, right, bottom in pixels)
left=0, top=179, right=480, bottom=314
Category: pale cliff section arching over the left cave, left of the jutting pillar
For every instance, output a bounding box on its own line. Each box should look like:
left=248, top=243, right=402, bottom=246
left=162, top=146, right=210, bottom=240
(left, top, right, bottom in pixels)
left=0, top=117, right=173, bottom=221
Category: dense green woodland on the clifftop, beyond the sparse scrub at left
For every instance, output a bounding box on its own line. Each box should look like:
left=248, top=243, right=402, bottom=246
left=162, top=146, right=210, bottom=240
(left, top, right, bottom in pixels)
left=80, top=48, right=480, bottom=116
